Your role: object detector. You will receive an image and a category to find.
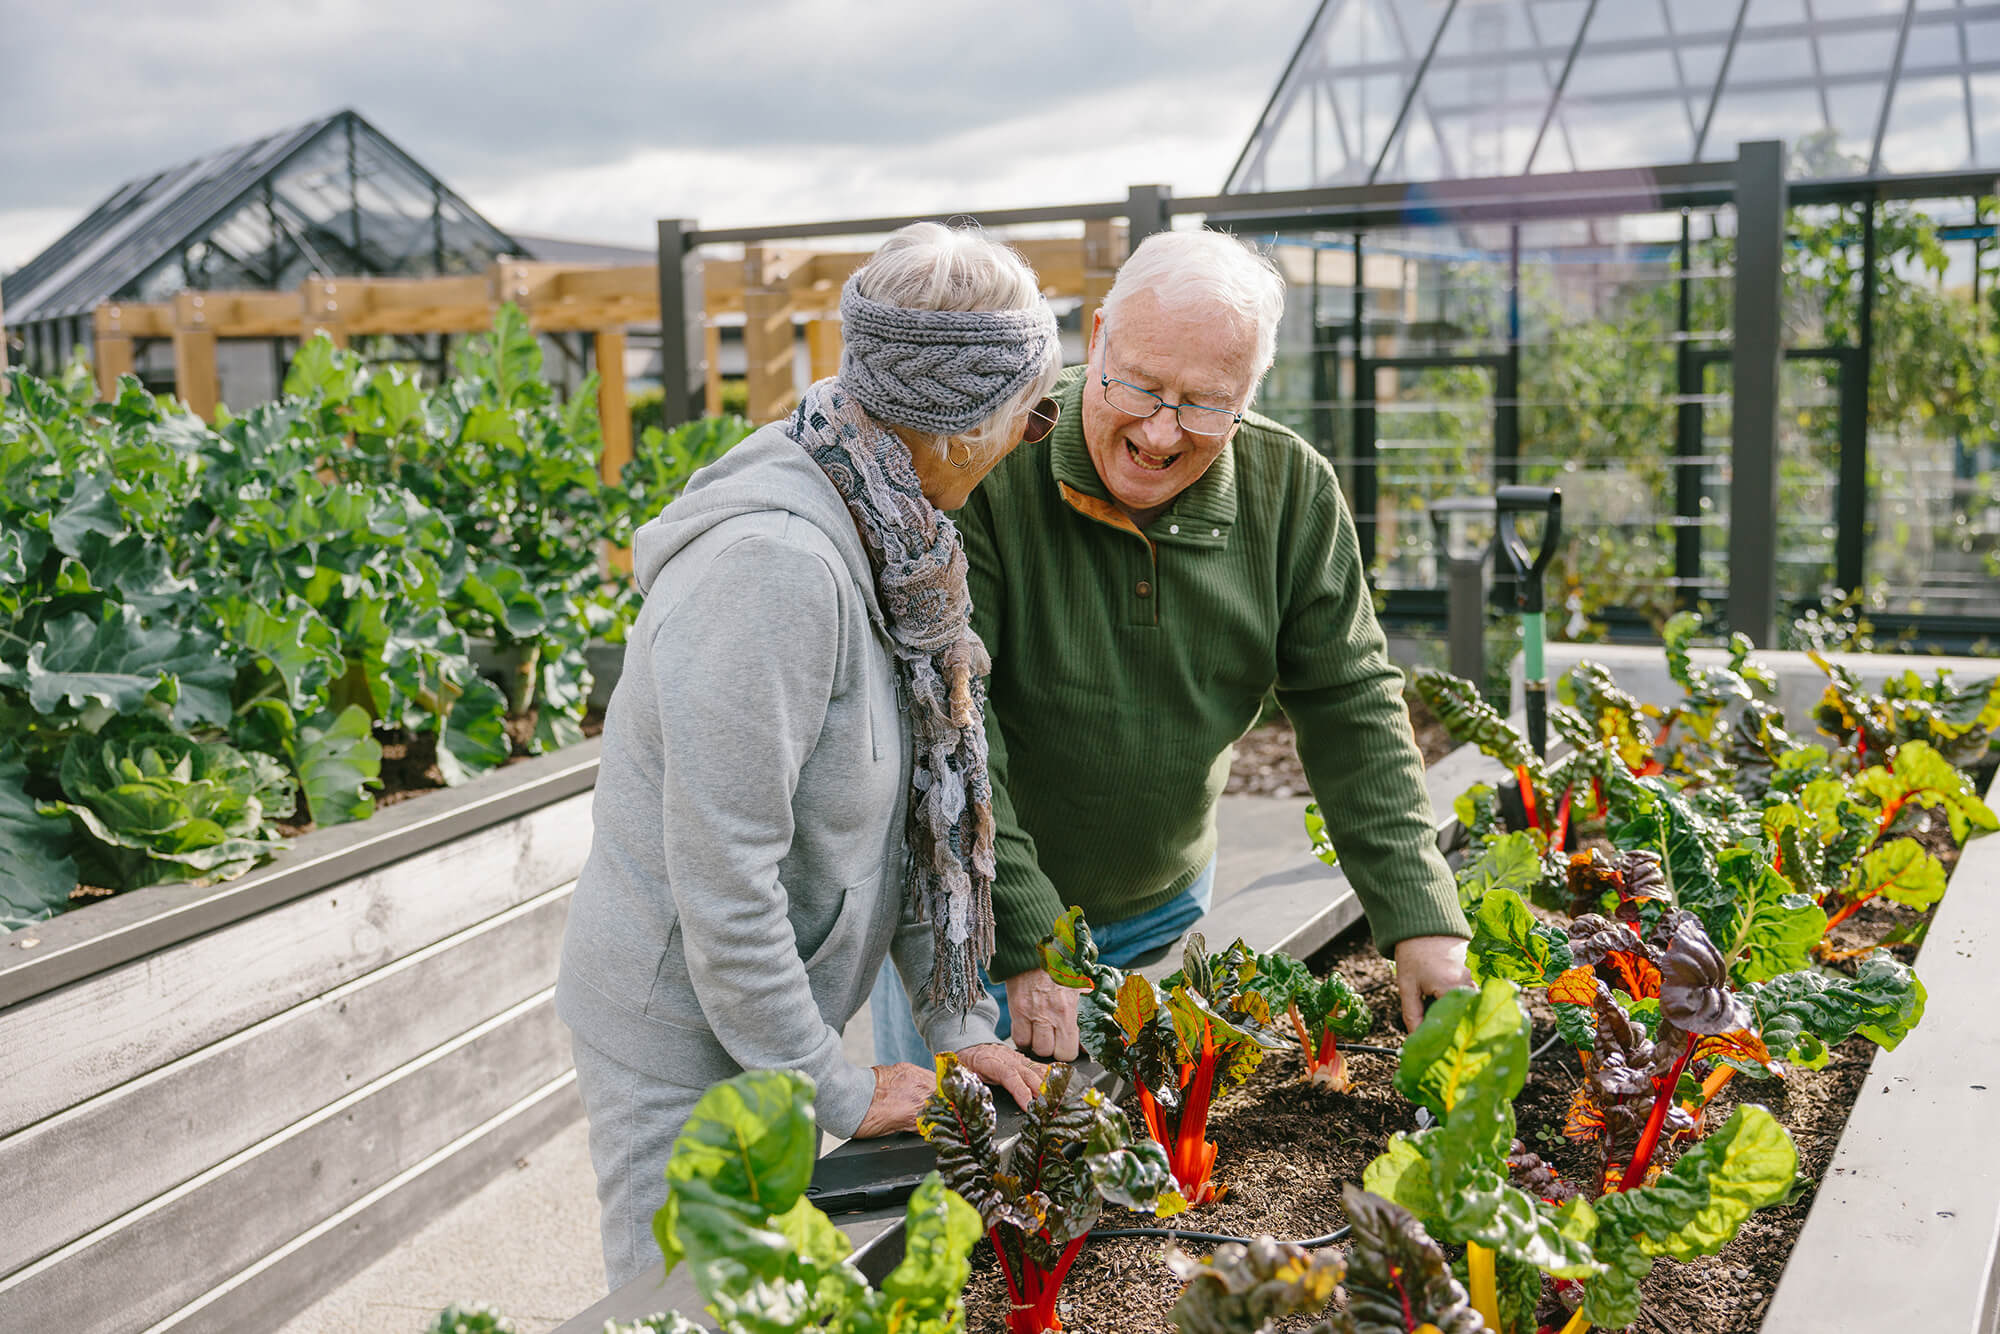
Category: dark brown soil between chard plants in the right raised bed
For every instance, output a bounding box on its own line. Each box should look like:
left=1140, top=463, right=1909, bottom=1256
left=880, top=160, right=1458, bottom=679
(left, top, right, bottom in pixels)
left=966, top=914, right=1874, bottom=1334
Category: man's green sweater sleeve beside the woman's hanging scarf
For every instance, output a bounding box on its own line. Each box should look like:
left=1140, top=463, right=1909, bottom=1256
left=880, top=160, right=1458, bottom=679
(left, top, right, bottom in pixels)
left=956, top=492, right=1066, bottom=982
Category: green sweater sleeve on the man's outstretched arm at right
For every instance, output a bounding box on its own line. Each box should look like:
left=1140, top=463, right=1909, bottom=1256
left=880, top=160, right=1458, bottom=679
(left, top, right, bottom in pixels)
left=1278, top=468, right=1472, bottom=954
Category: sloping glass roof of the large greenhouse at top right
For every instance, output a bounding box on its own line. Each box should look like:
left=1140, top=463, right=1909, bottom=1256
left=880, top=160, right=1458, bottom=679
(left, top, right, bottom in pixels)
left=1226, top=0, right=2000, bottom=192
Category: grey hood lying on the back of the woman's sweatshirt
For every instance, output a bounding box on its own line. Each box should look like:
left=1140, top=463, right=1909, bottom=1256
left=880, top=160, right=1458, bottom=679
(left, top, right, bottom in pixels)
left=632, top=422, right=884, bottom=626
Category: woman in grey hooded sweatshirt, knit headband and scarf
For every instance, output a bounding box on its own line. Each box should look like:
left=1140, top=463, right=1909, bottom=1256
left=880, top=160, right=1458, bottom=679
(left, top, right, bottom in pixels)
left=556, top=224, right=1060, bottom=1288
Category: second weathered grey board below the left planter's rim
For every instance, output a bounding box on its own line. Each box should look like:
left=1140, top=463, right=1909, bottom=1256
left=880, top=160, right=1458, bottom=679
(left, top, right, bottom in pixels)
left=0, top=886, right=570, bottom=1274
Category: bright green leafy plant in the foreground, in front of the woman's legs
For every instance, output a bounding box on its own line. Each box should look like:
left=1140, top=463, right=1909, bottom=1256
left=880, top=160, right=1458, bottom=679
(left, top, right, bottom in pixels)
left=638, top=1070, right=980, bottom=1334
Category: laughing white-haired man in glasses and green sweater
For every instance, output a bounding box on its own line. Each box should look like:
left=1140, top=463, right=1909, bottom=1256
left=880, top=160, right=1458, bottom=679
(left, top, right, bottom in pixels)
left=874, top=232, right=1472, bottom=1060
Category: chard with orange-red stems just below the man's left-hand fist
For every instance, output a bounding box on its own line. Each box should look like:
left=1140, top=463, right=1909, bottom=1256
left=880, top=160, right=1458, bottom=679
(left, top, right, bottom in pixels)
left=1042, top=908, right=1284, bottom=1204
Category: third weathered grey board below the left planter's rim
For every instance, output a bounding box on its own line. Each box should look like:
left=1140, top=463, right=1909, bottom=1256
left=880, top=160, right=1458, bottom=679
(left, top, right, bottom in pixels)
left=0, top=988, right=570, bottom=1334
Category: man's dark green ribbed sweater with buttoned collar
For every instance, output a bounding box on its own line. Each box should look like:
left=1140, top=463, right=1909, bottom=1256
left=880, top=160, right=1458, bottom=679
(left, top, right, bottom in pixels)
left=956, top=370, right=1470, bottom=978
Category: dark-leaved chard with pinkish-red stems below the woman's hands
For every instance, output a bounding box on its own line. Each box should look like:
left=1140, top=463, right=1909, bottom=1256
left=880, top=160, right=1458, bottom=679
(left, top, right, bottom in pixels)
left=918, top=1052, right=1186, bottom=1334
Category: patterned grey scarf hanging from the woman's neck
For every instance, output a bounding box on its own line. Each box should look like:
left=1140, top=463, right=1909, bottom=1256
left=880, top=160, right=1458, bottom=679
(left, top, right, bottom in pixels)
left=786, top=378, right=994, bottom=1016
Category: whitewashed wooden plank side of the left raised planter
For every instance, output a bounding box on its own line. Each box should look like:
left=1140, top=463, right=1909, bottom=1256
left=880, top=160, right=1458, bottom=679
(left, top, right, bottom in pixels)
left=0, top=742, right=598, bottom=1334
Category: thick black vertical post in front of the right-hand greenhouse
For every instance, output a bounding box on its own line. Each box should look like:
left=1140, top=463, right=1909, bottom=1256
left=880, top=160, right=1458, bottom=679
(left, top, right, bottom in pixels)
left=1728, top=140, right=1786, bottom=648
